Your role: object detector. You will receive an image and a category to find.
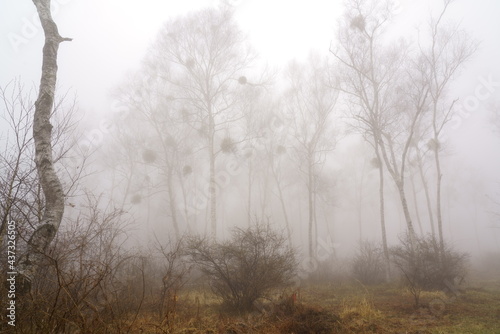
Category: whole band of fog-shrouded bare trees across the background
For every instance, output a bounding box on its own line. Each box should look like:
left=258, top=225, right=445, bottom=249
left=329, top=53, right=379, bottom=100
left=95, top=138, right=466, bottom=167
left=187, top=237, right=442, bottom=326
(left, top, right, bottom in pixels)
left=0, top=0, right=500, bottom=300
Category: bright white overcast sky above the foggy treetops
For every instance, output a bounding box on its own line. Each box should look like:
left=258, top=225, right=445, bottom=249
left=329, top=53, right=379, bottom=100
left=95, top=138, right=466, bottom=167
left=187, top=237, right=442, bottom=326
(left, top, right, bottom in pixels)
left=0, top=0, right=500, bottom=112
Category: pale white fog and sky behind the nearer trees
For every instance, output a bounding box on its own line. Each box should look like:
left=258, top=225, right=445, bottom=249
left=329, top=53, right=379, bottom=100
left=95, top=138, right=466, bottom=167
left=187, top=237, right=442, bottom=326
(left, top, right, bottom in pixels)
left=0, top=0, right=500, bottom=268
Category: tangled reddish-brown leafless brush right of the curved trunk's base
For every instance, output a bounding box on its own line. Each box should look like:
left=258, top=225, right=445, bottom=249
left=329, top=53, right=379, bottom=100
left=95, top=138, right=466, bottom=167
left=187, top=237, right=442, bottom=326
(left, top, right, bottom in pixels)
left=2, top=196, right=137, bottom=333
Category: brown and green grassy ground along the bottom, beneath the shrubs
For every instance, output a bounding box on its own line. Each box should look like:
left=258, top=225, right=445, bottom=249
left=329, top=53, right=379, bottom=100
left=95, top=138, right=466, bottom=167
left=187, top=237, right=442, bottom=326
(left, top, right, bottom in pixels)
left=128, top=281, right=500, bottom=334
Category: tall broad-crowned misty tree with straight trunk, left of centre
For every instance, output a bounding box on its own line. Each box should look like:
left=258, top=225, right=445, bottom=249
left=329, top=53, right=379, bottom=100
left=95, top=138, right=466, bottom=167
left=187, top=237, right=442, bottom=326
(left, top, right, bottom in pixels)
left=147, top=8, right=252, bottom=238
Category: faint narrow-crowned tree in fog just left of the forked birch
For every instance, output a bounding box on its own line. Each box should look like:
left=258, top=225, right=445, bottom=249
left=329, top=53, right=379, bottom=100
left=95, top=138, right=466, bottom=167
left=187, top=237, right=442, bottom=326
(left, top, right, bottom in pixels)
left=286, top=56, right=337, bottom=256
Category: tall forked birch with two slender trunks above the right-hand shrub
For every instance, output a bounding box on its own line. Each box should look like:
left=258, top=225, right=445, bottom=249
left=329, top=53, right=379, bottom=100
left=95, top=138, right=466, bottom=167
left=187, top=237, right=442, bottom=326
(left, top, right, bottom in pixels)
left=330, top=0, right=429, bottom=274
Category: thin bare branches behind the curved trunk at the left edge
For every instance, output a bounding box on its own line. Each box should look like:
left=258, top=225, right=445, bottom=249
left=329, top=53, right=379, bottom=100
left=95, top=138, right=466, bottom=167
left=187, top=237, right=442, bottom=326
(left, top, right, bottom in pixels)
left=0, top=79, right=82, bottom=249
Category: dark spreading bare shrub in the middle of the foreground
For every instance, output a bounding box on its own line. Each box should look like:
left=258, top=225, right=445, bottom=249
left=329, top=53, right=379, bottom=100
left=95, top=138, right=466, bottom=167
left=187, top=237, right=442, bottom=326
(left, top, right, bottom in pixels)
left=187, top=225, right=297, bottom=311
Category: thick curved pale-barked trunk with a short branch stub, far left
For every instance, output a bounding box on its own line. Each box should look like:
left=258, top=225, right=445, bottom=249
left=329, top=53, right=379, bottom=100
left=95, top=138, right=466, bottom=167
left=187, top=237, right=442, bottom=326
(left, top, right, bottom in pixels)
left=18, top=0, right=71, bottom=293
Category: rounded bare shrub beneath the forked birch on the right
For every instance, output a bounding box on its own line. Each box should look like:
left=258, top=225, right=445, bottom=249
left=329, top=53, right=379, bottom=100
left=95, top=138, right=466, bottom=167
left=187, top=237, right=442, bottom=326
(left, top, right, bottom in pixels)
left=391, top=235, right=468, bottom=307
